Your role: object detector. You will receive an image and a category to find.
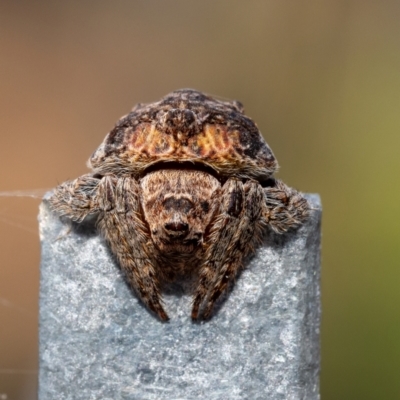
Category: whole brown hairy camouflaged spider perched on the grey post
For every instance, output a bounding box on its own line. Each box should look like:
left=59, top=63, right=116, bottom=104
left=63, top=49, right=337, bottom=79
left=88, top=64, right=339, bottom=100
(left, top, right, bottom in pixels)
left=50, top=89, right=309, bottom=320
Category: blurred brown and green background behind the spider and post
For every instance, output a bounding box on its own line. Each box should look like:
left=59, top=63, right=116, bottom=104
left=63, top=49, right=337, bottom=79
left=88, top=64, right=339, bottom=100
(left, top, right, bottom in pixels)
left=0, top=0, right=400, bottom=400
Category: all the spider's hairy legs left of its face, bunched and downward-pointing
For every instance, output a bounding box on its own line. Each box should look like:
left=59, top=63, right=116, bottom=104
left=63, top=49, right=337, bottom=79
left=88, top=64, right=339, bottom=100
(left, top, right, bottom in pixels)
left=49, top=174, right=168, bottom=321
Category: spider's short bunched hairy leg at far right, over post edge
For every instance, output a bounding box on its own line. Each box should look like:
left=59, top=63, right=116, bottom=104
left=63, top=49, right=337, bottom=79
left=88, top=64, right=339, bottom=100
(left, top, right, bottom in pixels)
left=263, top=179, right=310, bottom=234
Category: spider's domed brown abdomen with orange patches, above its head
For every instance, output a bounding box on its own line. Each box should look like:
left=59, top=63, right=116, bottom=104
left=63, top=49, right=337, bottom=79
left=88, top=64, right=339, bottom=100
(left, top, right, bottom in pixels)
left=89, top=89, right=278, bottom=180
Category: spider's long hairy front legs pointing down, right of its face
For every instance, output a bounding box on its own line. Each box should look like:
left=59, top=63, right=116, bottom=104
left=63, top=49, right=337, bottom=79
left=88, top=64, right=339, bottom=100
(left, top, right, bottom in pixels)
left=192, top=179, right=264, bottom=319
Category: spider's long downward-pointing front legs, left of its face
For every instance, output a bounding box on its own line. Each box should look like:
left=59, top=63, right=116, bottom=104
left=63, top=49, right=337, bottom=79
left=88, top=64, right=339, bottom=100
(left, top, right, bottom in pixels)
left=97, top=176, right=168, bottom=321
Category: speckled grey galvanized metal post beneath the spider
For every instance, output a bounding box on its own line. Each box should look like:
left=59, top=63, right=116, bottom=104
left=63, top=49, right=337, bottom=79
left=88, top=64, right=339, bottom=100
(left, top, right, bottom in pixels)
left=39, top=195, right=321, bottom=400
